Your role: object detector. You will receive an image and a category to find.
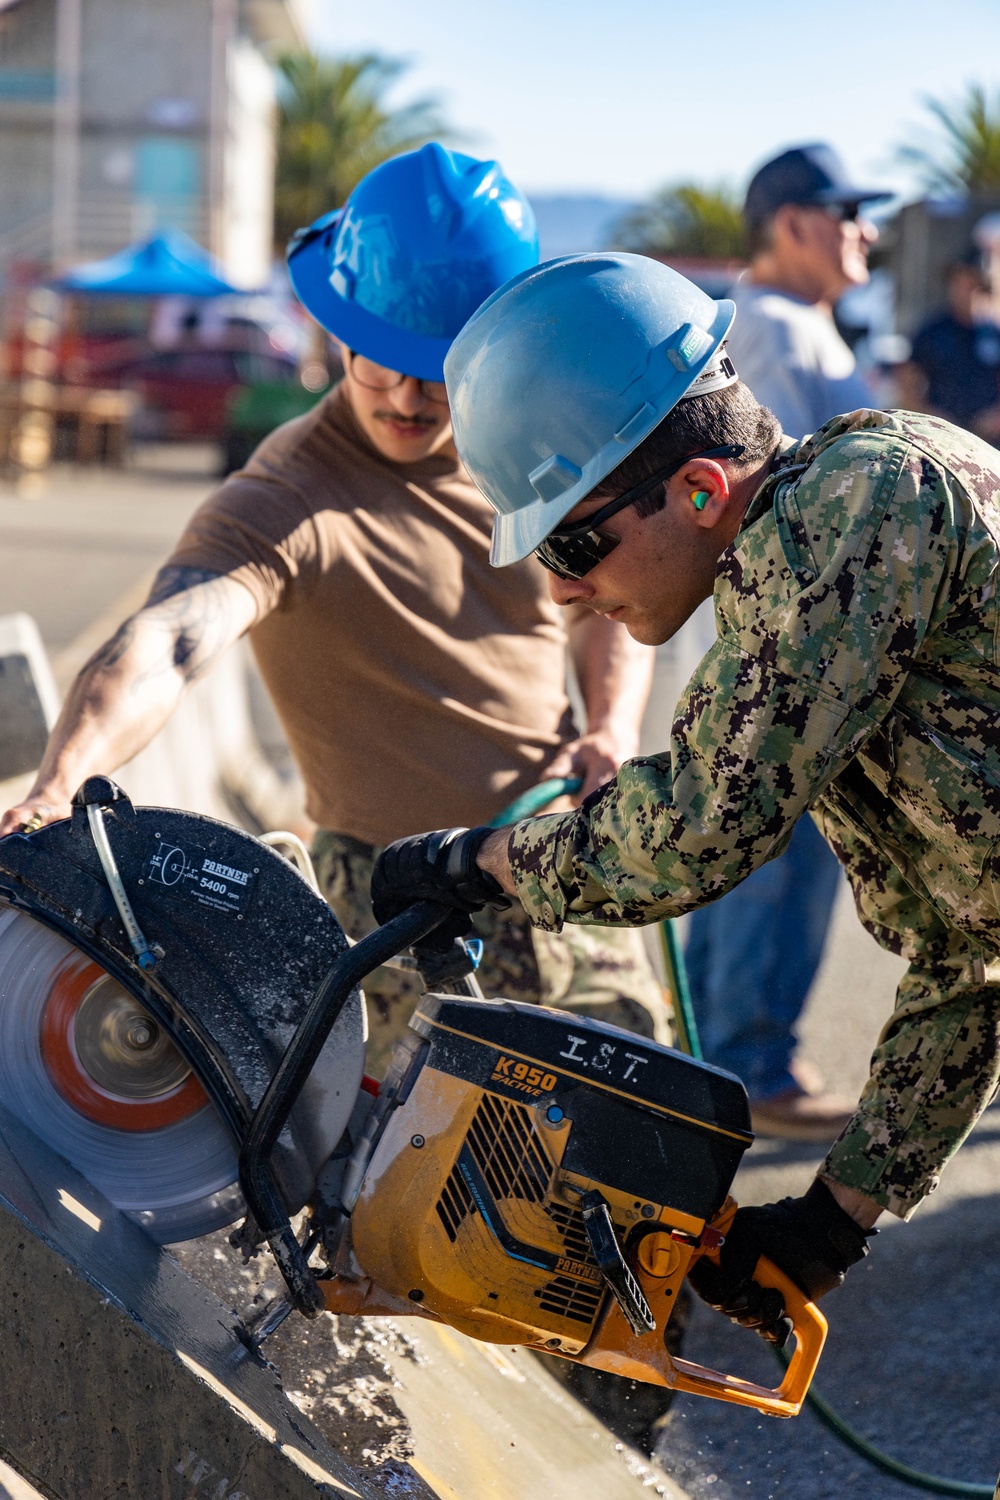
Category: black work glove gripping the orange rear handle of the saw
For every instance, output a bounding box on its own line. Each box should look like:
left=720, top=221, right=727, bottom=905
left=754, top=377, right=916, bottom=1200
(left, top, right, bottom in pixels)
left=688, top=1181, right=879, bottom=1349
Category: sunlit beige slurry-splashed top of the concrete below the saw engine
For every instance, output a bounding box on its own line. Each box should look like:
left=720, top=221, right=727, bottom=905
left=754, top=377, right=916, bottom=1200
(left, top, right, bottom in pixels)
left=171, top=1232, right=684, bottom=1500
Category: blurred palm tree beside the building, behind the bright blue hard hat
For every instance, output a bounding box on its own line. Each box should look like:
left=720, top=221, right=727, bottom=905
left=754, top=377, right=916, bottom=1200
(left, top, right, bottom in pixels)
left=274, top=53, right=451, bottom=246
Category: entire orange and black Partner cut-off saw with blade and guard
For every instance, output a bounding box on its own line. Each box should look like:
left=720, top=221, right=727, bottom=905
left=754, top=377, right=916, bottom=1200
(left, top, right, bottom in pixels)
left=0, top=777, right=826, bottom=1416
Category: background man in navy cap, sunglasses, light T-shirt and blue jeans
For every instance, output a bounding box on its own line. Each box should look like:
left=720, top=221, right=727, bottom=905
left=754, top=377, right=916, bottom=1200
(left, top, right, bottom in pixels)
left=685, top=146, right=886, bottom=1140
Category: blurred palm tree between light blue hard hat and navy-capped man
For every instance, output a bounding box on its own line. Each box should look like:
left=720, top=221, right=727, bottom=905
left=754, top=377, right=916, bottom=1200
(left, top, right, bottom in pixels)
left=613, top=183, right=748, bottom=260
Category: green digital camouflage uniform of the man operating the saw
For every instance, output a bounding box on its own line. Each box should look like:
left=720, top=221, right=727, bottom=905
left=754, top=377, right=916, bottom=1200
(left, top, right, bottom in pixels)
left=511, top=411, right=1000, bottom=1218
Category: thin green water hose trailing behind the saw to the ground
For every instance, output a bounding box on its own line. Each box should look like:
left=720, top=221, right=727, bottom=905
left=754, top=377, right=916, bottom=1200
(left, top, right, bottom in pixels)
left=490, top=777, right=1000, bottom=1500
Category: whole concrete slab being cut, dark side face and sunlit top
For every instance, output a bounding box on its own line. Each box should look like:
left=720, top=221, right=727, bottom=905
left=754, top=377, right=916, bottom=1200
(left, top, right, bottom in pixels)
left=0, top=1109, right=682, bottom=1500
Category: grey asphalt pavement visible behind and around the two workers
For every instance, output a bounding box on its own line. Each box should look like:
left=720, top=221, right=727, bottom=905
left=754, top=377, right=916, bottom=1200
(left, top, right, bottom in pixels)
left=0, top=453, right=1000, bottom=1500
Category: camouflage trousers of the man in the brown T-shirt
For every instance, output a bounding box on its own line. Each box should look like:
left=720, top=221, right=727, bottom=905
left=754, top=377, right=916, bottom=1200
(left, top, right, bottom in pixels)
left=312, top=830, right=670, bottom=1077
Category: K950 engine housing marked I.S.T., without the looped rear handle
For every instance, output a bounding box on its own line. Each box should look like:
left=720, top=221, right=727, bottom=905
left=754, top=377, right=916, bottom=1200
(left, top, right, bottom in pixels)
left=341, top=995, right=753, bottom=1355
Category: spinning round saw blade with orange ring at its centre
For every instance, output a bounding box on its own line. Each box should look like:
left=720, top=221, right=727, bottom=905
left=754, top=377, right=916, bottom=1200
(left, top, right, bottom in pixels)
left=0, top=909, right=243, bottom=1245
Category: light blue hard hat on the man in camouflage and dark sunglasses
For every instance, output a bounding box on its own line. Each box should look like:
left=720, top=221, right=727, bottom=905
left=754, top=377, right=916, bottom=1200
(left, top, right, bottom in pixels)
left=445, top=254, right=736, bottom=567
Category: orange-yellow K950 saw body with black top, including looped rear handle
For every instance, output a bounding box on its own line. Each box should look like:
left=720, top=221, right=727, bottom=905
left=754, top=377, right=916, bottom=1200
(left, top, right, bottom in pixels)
left=319, top=995, right=826, bottom=1416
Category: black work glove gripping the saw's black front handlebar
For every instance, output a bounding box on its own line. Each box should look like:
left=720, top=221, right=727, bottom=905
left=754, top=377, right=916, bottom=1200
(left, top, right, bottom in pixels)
left=372, top=828, right=510, bottom=938
